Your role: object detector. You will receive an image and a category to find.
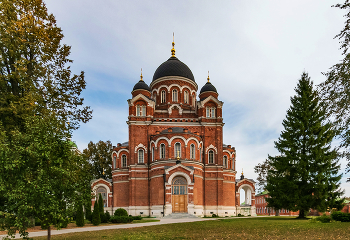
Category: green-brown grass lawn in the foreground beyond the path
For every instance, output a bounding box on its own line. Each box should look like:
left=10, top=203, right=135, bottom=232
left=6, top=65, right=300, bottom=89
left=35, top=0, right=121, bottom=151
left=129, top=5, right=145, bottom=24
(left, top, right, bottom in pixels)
left=34, top=217, right=350, bottom=240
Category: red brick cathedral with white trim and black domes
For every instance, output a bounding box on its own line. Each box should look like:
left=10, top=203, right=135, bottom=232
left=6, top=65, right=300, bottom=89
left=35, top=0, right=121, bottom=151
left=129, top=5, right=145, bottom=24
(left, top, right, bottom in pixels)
left=92, top=39, right=256, bottom=217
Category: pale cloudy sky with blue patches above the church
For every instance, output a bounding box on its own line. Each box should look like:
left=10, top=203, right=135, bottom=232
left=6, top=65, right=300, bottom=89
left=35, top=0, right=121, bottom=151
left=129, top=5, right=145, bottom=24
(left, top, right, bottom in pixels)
left=45, top=0, right=350, bottom=197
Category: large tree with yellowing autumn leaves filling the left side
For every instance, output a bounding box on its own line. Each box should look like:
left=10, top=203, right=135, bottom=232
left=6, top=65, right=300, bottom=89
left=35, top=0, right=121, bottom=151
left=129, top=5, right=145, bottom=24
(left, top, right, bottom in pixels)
left=0, top=0, right=92, bottom=238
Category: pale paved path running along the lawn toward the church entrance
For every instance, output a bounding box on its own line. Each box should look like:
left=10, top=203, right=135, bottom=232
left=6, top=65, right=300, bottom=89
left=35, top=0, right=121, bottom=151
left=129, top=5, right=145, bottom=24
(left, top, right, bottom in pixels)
left=0, top=218, right=216, bottom=239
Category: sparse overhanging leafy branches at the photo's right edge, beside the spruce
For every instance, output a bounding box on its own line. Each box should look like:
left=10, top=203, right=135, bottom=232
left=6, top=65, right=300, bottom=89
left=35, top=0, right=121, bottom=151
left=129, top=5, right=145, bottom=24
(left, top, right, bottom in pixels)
left=319, top=0, right=350, bottom=181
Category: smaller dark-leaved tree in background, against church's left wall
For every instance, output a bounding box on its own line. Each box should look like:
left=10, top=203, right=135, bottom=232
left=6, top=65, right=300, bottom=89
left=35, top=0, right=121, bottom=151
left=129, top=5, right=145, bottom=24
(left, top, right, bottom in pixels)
left=83, top=141, right=112, bottom=179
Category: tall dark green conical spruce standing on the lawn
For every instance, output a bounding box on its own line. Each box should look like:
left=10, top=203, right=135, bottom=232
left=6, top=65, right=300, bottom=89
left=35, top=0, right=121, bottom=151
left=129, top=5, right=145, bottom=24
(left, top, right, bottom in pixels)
left=266, top=73, right=343, bottom=218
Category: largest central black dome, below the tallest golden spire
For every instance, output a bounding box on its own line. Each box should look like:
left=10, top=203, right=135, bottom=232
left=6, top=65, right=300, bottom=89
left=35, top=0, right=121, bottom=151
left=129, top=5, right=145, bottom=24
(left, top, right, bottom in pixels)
left=153, top=57, right=194, bottom=81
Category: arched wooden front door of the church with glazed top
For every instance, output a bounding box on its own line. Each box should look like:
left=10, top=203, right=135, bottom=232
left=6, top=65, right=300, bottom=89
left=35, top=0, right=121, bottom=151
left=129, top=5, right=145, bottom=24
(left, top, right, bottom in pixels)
left=171, top=177, right=187, bottom=212
